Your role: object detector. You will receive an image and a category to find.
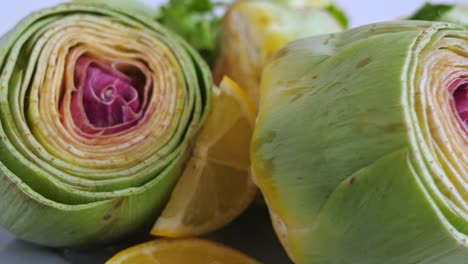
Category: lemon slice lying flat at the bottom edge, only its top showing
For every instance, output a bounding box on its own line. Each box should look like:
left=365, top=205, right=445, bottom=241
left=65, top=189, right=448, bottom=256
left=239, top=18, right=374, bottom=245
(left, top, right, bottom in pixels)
left=106, top=239, right=260, bottom=264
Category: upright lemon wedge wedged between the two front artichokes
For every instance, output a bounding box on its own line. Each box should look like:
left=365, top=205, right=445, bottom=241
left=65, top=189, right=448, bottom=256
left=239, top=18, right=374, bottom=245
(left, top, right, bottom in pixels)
left=151, top=77, right=257, bottom=238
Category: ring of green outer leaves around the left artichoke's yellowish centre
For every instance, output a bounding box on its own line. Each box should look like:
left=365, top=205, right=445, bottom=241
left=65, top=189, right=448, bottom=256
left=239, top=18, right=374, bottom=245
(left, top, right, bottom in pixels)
left=0, top=3, right=212, bottom=247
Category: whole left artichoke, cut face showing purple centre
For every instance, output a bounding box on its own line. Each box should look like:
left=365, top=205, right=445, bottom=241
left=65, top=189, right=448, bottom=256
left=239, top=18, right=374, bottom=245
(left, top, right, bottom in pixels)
left=0, top=1, right=212, bottom=246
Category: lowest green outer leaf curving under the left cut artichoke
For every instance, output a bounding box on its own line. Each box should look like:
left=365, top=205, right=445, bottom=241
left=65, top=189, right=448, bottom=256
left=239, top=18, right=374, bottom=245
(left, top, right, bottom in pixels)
left=0, top=155, right=183, bottom=247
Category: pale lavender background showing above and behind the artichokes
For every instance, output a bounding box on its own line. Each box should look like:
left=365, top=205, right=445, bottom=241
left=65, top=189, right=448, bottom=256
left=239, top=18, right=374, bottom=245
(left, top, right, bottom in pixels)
left=0, top=0, right=468, bottom=34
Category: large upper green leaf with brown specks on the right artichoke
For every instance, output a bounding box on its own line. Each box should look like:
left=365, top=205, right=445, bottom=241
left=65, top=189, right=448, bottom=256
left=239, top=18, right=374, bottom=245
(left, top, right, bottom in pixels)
left=253, top=20, right=419, bottom=228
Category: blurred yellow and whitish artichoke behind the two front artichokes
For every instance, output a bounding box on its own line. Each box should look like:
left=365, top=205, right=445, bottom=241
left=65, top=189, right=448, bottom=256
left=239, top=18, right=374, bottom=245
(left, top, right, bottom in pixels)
left=213, top=1, right=343, bottom=111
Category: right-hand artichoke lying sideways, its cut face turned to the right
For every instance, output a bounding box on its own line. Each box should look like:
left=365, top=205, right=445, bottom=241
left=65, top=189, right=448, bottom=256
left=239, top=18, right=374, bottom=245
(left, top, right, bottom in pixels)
left=251, top=21, right=468, bottom=264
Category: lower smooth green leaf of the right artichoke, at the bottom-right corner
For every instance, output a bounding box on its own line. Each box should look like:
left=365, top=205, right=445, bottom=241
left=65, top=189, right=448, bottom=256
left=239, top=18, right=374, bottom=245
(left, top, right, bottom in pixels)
left=298, top=150, right=468, bottom=264
